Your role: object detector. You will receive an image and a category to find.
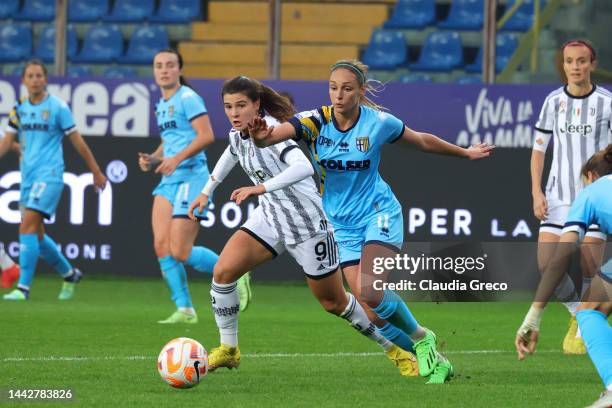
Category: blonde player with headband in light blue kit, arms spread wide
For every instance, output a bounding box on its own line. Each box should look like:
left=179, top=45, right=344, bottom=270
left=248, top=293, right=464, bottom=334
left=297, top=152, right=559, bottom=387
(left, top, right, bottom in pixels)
left=249, top=60, right=493, bottom=384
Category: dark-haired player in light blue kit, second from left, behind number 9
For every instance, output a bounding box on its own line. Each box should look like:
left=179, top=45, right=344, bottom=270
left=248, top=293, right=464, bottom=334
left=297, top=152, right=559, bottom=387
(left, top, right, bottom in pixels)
left=138, top=50, right=225, bottom=323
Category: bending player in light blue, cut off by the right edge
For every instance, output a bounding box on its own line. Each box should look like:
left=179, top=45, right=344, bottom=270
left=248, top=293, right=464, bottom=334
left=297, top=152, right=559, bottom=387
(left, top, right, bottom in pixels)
left=515, top=144, right=612, bottom=408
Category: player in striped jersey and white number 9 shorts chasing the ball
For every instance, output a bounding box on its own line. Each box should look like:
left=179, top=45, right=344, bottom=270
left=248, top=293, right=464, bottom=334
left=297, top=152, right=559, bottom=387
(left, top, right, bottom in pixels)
left=189, top=76, right=418, bottom=375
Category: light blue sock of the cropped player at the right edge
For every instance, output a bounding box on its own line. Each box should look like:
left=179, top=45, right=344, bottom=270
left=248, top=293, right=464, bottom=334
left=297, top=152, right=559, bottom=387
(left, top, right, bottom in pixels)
left=576, top=310, right=612, bottom=387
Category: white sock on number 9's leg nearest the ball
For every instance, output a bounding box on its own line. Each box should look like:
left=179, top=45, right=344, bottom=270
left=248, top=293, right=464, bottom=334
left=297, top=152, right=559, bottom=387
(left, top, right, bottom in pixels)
left=210, top=279, right=240, bottom=347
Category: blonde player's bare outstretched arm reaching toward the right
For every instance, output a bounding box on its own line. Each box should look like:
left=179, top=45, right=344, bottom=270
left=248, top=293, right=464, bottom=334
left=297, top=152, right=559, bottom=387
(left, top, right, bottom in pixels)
left=401, top=126, right=495, bottom=160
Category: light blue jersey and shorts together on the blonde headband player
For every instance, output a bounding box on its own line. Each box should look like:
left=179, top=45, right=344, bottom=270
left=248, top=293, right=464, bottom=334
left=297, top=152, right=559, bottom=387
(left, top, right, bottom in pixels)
left=289, top=106, right=404, bottom=267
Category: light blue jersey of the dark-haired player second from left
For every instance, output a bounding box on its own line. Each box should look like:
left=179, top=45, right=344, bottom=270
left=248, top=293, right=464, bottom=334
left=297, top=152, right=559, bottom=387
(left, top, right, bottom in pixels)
left=155, top=85, right=208, bottom=184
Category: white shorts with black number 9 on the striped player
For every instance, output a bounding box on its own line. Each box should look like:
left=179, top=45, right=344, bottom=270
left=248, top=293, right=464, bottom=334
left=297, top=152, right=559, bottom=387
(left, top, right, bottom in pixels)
left=240, top=206, right=338, bottom=279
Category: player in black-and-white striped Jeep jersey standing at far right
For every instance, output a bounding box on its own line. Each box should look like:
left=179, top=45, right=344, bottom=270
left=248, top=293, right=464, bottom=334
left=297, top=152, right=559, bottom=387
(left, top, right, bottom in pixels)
left=531, top=40, right=612, bottom=354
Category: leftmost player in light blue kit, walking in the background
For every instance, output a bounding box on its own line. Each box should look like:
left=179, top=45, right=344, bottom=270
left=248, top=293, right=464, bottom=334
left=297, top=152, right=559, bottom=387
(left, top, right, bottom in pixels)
left=0, top=60, right=106, bottom=300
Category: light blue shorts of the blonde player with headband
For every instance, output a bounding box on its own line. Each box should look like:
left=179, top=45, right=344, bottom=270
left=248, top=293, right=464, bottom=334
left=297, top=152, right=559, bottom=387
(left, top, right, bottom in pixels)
left=334, top=208, right=404, bottom=267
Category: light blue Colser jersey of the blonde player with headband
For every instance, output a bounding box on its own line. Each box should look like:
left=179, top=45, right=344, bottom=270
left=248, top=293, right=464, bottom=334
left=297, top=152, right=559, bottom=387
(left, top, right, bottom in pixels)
left=290, top=106, right=404, bottom=227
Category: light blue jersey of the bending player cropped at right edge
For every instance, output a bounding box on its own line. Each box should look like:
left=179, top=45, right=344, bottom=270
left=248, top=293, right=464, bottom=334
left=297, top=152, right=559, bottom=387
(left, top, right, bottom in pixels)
left=564, top=174, right=612, bottom=236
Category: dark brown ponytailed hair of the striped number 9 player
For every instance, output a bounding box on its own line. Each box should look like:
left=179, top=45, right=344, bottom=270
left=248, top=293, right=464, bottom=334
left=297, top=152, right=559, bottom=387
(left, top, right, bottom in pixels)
left=221, top=76, right=295, bottom=122
